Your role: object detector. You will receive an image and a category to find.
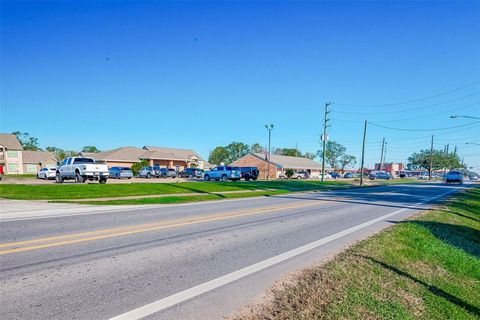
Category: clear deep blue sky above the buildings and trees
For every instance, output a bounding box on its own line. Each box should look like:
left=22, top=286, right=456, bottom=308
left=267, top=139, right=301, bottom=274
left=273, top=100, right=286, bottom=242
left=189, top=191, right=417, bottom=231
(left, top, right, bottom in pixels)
left=0, top=1, right=480, bottom=170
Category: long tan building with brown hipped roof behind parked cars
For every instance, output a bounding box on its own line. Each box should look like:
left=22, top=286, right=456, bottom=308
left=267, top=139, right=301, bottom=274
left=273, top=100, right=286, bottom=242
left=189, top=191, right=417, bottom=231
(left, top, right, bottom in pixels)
left=81, top=146, right=210, bottom=171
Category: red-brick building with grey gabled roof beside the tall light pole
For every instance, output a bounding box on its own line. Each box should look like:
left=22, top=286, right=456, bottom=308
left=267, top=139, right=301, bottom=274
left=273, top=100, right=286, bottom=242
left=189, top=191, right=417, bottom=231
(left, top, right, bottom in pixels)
left=230, top=153, right=322, bottom=179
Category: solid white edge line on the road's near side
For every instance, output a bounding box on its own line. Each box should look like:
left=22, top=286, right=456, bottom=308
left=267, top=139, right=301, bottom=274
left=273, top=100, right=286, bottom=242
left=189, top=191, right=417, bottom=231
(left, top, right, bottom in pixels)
left=110, top=187, right=463, bottom=320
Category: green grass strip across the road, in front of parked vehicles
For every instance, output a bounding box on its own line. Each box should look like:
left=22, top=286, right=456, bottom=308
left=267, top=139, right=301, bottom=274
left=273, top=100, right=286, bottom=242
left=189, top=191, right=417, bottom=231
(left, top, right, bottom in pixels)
left=0, top=181, right=352, bottom=201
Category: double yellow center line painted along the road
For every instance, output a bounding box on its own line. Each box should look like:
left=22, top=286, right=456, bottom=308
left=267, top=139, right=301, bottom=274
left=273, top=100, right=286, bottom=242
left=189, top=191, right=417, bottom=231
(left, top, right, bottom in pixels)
left=0, top=200, right=325, bottom=255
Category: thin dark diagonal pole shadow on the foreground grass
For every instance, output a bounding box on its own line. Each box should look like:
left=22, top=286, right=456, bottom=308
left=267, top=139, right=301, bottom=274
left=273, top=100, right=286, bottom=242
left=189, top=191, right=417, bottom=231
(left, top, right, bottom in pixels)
left=356, top=255, right=480, bottom=316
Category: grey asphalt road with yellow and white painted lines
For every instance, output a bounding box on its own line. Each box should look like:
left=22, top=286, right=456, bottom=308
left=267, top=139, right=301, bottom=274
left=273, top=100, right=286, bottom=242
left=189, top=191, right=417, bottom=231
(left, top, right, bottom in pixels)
left=0, top=184, right=460, bottom=320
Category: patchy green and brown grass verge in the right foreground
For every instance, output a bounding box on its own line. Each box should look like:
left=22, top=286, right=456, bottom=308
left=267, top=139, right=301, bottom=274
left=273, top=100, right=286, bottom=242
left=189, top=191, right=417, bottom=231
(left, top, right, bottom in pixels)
left=233, top=188, right=480, bottom=319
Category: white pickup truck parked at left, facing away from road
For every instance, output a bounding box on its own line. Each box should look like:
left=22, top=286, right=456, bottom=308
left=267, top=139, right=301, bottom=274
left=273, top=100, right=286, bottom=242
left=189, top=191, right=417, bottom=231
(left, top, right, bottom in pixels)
left=55, top=157, right=109, bottom=184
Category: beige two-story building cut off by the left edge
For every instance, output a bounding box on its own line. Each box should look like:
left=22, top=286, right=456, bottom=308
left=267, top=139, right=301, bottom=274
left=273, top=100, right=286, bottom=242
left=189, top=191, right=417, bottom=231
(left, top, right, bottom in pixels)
left=0, top=133, right=23, bottom=174
